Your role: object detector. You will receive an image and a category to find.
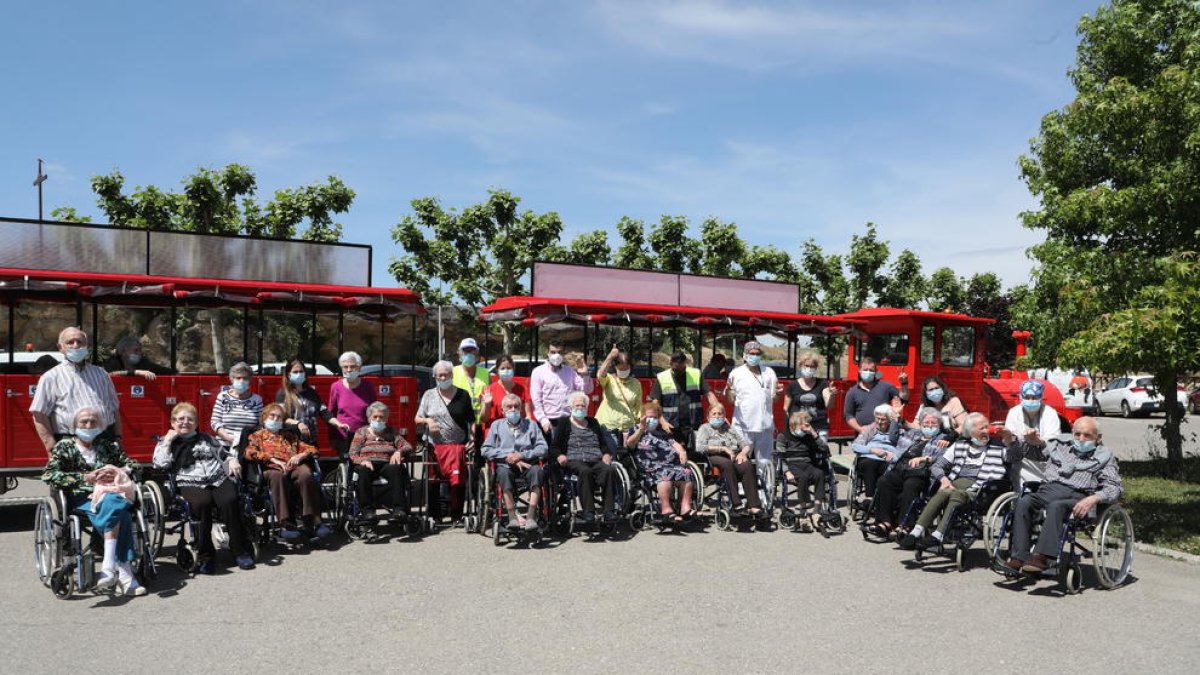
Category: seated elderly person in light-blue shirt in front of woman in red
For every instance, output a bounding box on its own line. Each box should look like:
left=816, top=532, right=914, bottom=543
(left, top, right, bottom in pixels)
left=482, top=394, right=547, bottom=531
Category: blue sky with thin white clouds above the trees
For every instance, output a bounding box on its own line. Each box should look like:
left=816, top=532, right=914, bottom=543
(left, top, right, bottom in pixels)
left=0, top=0, right=1099, bottom=291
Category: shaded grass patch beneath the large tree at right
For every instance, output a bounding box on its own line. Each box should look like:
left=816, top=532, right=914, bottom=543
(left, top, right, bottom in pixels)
left=1121, top=458, right=1200, bottom=555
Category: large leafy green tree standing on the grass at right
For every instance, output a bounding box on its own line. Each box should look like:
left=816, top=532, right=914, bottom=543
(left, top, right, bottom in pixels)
left=1020, top=0, right=1200, bottom=460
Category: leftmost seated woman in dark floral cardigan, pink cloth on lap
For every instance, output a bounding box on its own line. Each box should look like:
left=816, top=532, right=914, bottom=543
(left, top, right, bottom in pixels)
left=42, top=407, right=146, bottom=596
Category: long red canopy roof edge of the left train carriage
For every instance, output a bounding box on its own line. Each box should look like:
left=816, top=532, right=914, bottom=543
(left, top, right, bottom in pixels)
left=0, top=268, right=425, bottom=316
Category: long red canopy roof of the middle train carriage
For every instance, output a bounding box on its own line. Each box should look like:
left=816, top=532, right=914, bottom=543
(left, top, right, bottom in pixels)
left=479, top=295, right=865, bottom=335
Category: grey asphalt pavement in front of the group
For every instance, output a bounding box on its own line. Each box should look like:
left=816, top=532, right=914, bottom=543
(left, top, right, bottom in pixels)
left=0, top=413, right=1200, bottom=674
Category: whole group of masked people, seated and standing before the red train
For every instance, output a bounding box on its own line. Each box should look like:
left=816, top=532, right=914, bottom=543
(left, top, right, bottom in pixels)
left=30, top=328, right=1121, bottom=595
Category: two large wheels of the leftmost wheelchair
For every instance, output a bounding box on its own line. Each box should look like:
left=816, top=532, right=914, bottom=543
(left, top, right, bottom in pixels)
left=34, top=484, right=162, bottom=599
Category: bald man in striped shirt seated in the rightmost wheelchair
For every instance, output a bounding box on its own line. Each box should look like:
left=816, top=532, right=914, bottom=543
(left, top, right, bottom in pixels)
left=1004, top=417, right=1121, bottom=574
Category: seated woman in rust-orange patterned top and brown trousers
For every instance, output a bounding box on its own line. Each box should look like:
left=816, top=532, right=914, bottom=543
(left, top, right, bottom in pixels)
left=245, top=404, right=332, bottom=539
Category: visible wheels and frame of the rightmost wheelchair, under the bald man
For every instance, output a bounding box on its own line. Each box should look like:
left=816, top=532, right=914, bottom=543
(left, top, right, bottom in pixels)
left=984, top=483, right=1134, bottom=595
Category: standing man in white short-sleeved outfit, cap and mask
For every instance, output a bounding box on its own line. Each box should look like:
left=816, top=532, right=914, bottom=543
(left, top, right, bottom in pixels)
left=725, top=340, right=784, bottom=466
